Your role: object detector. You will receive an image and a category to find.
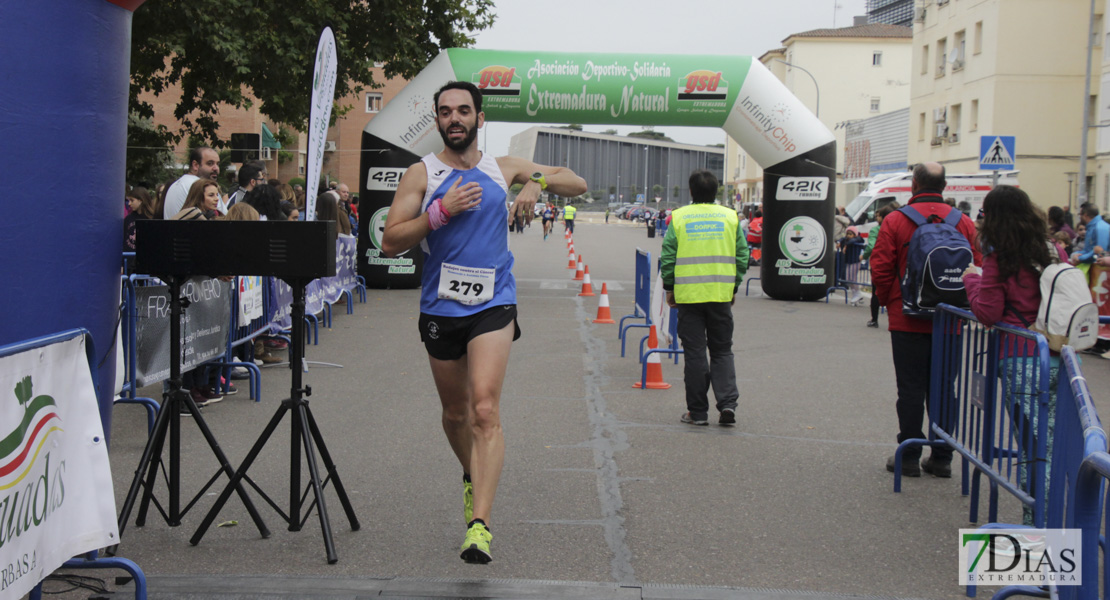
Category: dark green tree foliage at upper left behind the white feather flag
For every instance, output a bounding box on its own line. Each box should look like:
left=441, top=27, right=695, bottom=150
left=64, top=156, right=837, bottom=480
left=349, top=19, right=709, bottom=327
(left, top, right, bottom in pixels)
left=129, top=0, right=494, bottom=146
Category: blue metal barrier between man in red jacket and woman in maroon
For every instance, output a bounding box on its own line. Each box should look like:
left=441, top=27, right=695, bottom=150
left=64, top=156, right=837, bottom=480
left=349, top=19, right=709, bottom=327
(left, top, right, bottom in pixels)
left=895, top=304, right=1050, bottom=527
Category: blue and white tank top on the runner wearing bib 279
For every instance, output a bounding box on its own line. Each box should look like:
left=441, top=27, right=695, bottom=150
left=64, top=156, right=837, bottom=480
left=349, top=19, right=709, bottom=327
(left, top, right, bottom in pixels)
left=420, top=154, right=516, bottom=317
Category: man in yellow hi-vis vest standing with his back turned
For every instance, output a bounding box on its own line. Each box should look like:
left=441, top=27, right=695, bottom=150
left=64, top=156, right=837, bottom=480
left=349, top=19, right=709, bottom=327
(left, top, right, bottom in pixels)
left=659, top=170, right=748, bottom=426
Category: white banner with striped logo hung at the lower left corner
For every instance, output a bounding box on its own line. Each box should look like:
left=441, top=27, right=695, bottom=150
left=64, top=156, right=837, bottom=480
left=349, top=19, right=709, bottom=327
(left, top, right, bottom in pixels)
left=0, top=336, right=119, bottom=598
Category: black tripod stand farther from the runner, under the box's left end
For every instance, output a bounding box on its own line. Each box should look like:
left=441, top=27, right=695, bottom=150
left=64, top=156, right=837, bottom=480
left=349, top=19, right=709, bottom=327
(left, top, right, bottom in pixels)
left=119, top=275, right=270, bottom=538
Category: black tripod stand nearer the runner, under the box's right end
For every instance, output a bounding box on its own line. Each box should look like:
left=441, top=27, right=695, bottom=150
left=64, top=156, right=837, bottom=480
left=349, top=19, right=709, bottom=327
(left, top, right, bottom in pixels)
left=189, top=277, right=361, bottom=565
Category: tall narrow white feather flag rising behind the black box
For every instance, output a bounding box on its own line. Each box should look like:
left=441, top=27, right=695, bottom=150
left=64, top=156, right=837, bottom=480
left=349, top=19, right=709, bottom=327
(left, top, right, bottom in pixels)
left=304, top=27, right=339, bottom=221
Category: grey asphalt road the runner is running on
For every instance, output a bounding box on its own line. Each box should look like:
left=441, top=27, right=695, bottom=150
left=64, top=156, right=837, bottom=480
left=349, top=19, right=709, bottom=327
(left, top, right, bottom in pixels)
left=48, top=221, right=1110, bottom=600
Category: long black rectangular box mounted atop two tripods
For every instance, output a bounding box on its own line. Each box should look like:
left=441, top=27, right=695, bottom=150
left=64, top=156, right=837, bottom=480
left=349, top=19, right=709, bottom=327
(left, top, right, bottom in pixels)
left=135, top=220, right=335, bottom=279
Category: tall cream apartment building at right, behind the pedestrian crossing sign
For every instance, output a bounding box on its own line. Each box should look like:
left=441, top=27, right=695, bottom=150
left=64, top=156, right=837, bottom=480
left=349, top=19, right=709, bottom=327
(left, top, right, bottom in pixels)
left=908, top=0, right=1110, bottom=210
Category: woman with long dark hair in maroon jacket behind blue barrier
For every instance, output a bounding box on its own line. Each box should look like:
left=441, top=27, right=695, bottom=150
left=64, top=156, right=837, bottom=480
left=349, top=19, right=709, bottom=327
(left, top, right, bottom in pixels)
left=963, top=185, right=1068, bottom=523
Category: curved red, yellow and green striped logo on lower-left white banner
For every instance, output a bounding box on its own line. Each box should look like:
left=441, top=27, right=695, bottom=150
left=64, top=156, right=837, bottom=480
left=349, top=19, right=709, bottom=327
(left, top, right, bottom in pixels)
left=0, top=376, right=61, bottom=491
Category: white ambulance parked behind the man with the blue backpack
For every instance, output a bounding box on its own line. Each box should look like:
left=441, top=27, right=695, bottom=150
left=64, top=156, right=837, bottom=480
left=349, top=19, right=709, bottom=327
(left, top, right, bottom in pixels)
left=845, top=171, right=1018, bottom=234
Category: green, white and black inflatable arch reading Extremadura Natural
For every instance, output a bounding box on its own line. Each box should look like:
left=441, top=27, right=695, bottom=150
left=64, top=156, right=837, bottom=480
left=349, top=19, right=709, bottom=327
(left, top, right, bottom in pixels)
left=359, top=49, right=836, bottom=299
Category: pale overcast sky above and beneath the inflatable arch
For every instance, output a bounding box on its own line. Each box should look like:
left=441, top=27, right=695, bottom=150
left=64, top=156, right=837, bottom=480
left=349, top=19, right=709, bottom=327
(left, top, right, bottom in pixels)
left=474, top=0, right=867, bottom=156
